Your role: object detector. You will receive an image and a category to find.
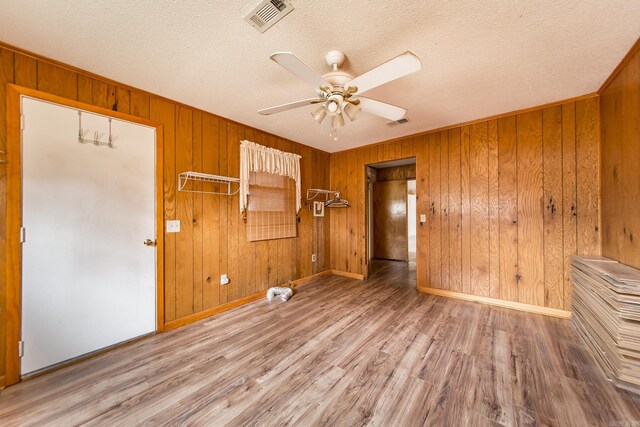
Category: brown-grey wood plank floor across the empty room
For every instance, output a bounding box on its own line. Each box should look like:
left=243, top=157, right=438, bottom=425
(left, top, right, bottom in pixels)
left=0, top=262, right=640, bottom=426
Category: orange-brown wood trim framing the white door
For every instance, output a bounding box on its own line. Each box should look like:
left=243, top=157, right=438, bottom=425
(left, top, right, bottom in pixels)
left=4, top=84, right=164, bottom=385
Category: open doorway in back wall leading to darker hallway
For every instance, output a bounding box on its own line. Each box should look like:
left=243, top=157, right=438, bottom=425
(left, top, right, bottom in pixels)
left=367, top=158, right=416, bottom=270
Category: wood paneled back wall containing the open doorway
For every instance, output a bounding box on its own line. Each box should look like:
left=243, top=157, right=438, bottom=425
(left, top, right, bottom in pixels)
left=331, top=96, right=600, bottom=309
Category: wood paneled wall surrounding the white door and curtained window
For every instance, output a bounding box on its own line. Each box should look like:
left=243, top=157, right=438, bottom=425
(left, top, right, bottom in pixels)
left=0, top=48, right=330, bottom=379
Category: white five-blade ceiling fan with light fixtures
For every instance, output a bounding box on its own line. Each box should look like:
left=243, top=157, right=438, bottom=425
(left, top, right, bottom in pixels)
left=258, top=50, right=422, bottom=141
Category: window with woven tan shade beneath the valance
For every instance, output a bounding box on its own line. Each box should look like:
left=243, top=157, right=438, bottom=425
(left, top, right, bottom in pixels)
left=247, top=172, right=297, bottom=242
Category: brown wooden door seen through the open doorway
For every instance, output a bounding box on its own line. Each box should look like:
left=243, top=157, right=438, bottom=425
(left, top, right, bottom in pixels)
left=373, top=180, right=408, bottom=261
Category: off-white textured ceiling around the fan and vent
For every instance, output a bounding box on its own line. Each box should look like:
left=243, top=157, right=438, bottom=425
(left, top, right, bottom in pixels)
left=0, top=0, right=640, bottom=152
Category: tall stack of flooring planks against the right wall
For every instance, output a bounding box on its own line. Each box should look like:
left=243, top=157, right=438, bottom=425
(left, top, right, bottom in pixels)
left=571, top=256, right=640, bottom=392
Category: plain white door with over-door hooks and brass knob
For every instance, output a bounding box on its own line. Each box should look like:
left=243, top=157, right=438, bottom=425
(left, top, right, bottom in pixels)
left=21, top=97, right=156, bottom=375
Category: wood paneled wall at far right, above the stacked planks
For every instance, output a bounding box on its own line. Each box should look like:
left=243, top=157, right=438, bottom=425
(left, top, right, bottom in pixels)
left=600, top=40, right=640, bottom=268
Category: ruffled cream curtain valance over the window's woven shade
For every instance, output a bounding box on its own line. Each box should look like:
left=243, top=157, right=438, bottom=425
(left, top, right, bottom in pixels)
left=240, top=140, right=302, bottom=212
